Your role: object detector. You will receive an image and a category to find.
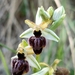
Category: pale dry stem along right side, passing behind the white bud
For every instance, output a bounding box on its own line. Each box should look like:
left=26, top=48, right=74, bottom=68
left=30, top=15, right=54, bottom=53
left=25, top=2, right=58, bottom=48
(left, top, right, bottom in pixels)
left=54, top=0, right=75, bottom=74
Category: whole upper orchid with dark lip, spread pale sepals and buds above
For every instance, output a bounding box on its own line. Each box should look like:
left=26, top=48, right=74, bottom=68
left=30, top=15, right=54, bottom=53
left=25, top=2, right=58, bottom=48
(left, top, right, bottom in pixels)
left=20, top=7, right=65, bottom=54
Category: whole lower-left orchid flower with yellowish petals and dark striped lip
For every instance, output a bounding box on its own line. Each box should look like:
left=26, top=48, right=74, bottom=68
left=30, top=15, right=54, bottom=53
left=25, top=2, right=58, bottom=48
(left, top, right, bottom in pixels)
left=11, top=40, right=41, bottom=75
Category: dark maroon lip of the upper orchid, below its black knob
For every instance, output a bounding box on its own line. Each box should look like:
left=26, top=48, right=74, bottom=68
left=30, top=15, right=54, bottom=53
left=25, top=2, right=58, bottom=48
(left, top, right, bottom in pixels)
left=29, top=36, right=46, bottom=54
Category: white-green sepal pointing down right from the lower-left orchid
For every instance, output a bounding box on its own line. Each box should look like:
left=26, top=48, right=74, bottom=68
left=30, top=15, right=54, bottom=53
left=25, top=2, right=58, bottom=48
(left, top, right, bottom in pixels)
left=26, top=55, right=41, bottom=69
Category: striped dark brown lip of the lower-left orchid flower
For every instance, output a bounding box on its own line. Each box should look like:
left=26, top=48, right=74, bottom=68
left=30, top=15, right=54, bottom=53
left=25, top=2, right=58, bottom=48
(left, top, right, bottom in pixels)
left=11, top=58, right=29, bottom=75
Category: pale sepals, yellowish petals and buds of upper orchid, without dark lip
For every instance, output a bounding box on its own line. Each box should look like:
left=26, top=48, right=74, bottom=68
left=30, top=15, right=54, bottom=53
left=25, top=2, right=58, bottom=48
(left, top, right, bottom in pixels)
left=20, top=6, right=65, bottom=42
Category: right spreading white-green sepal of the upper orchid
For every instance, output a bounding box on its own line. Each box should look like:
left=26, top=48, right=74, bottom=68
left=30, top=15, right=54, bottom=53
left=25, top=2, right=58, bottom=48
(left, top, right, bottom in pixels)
left=42, top=28, right=59, bottom=42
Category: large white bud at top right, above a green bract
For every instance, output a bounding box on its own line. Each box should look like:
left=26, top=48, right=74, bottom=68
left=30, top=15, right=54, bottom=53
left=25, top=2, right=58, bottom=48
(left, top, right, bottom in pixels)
left=53, top=6, right=65, bottom=20
